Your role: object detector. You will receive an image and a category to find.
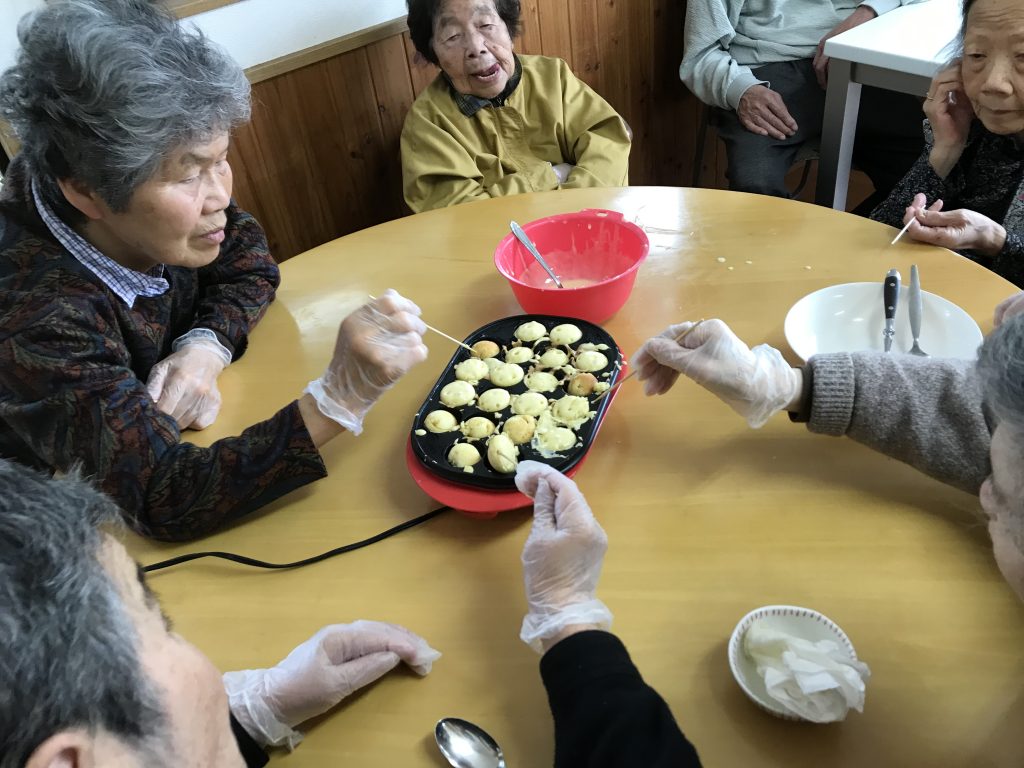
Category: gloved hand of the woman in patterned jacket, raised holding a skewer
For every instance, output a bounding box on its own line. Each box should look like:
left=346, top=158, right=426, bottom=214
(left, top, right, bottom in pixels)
left=305, top=289, right=427, bottom=434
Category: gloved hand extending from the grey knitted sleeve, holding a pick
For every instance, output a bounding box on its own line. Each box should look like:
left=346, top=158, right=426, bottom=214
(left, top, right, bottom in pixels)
left=633, top=319, right=803, bottom=427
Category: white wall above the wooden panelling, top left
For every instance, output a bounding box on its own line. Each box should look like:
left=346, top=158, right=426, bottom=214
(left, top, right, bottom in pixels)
left=0, top=0, right=406, bottom=69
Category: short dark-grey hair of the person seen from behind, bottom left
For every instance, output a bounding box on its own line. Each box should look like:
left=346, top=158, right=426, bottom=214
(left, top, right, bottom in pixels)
left=0, top=460, right=165, bottom=768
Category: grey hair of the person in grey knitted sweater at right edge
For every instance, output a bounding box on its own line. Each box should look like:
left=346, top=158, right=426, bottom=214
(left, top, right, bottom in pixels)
left=978, top=314, right=1024, bottom=435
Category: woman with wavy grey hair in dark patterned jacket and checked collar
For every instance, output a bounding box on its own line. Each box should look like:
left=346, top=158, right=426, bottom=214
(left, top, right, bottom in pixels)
left=0, top=0, right=426, bottom=540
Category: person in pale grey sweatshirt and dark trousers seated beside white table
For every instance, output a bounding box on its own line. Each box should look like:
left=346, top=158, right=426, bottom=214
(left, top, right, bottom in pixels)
left=679, top=0, right=922, bottom=210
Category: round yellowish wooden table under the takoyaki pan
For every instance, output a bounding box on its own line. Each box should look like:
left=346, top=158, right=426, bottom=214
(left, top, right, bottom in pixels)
left=129, top=187, right=1024, bottom=768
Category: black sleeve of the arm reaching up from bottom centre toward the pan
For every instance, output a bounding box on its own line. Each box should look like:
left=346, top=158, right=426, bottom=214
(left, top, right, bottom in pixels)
left=541, top=631, right=700, bottom=768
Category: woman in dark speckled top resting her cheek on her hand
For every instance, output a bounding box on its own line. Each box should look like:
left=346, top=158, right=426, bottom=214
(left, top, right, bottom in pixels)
left=871, top=0, right=1024, bottom=286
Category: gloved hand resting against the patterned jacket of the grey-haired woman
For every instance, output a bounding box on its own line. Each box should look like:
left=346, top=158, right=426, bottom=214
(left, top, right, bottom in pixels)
left=145, top=331, right=231, bottom=429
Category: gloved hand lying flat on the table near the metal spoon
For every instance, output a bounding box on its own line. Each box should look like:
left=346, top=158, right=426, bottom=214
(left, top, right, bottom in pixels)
left=224, top=621, right=441, bottom=750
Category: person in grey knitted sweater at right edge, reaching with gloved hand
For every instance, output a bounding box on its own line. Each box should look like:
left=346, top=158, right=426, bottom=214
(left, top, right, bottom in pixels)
left=635, top=309, right=1024, bottom=600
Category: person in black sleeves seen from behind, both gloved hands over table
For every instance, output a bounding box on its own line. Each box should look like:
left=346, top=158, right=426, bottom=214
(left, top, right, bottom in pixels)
left=0, top=461, right=700, bottom=768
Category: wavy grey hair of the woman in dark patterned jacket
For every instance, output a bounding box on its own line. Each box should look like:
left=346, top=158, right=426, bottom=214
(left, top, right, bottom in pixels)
left=0, top=0, right=250, bottom=222
